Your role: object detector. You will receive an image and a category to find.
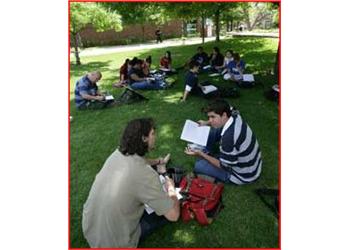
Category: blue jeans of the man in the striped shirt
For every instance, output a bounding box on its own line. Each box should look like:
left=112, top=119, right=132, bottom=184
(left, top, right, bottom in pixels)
left=193, top=128, right=230, bottom=182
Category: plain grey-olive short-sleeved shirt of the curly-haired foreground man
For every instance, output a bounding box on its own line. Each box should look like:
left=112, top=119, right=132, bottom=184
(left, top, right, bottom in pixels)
left=82, top=149, right=174, bottom=248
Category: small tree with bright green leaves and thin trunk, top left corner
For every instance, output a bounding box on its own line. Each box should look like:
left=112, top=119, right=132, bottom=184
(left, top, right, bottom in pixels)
left=69, top=2, right=122, bottom=65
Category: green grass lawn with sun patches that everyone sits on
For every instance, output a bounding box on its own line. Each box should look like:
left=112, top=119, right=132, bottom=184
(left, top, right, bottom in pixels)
left=70, top=38, right=279, bottom=248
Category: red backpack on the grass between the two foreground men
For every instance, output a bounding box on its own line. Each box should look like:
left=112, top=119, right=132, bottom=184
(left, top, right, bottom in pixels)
left=180, top=175, right=224, bottom=226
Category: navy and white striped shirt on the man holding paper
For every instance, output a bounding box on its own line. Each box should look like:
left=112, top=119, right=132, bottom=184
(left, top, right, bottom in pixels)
left=219, top=112, right=262, bottom=184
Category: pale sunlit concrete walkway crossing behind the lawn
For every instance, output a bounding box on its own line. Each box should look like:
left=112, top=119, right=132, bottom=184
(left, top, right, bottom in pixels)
left=71, top=32, right=278, bottom=57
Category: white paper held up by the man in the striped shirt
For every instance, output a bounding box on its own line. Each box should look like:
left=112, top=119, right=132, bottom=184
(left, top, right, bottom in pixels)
left=180, top=120, right=210, bottom=146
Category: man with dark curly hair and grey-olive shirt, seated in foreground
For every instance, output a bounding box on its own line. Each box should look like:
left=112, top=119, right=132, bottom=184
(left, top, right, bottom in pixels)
left=82, top=118, right=180, bottom=248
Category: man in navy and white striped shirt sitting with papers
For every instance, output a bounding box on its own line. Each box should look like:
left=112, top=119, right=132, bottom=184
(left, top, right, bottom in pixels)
left=185, top=100, right=262, bottom=185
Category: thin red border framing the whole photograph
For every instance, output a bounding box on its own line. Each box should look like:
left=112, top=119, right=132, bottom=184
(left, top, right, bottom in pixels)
left=68, top=0, right=282, bottom=250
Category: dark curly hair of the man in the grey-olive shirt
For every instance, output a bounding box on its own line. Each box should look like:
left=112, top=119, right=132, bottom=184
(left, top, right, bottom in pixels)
left=119, top=118, right=155, bottom=156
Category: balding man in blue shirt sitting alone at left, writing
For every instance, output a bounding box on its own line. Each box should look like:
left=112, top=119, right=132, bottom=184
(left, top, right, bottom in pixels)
left=74, top=71, right=114, bottom=110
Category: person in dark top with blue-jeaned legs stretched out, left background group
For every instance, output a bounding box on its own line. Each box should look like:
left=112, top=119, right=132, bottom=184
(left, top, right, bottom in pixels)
left=128, top=58, right=166, bottom=90
